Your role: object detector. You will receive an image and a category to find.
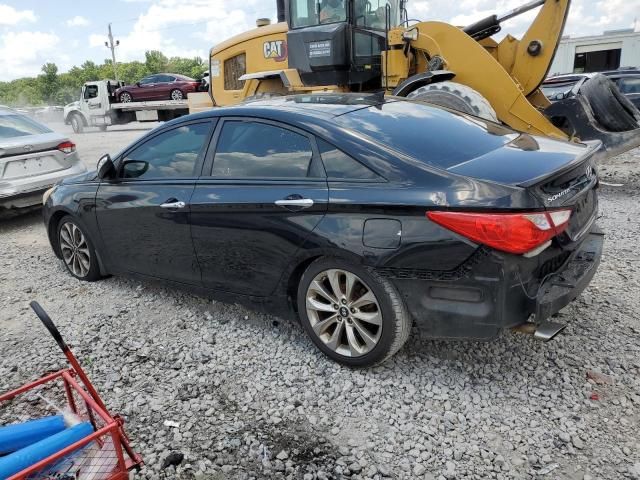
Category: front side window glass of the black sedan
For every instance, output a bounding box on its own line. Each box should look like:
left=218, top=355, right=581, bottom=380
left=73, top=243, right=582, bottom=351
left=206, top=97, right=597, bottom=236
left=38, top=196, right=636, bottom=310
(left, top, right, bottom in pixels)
left=121, top=122, right=211, bottom=180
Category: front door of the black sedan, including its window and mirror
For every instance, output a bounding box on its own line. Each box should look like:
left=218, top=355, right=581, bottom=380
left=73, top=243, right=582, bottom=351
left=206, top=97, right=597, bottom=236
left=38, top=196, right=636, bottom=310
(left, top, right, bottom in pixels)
left=96, top=120, right=213, bottom=285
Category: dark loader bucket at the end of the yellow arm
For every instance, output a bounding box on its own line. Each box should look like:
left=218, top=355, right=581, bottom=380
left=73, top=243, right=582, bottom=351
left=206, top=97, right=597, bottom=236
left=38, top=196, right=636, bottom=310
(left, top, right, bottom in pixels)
left=544, top=75, right=640, bottom=157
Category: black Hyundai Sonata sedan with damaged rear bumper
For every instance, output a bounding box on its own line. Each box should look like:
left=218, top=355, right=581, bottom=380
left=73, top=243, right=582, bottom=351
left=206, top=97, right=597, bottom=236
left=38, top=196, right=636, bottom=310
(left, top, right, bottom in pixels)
left=44, top=94, right=603, bottom=366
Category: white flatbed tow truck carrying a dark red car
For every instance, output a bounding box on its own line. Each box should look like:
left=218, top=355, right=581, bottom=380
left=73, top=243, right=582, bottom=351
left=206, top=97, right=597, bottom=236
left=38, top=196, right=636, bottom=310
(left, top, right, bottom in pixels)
left=64, top=80, right=189, bottom=133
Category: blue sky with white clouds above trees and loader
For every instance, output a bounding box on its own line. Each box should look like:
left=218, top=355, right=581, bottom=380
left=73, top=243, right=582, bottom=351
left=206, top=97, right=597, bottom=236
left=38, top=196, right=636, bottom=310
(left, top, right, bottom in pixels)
left=0, top=0, right=640, bottom=81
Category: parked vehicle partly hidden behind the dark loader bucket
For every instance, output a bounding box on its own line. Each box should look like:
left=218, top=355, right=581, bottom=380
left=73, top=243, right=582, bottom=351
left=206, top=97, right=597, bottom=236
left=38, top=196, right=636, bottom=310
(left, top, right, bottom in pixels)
left=541, top=68, right=640, bottom=108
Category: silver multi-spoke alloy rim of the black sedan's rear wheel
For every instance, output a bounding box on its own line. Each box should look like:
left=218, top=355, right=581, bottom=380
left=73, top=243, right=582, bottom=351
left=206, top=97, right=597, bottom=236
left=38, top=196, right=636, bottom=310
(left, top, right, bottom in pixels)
left=306, top=269, right=382, bottom=357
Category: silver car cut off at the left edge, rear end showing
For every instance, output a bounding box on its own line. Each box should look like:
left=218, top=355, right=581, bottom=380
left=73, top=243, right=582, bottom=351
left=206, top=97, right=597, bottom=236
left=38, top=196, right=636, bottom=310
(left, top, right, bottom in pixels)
left=0, top=108, right=86, bottom=216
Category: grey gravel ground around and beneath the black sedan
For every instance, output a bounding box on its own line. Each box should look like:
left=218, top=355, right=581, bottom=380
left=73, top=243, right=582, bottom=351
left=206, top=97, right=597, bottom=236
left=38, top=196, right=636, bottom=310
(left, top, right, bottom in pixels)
left=0, top=124, right=640, bottom=480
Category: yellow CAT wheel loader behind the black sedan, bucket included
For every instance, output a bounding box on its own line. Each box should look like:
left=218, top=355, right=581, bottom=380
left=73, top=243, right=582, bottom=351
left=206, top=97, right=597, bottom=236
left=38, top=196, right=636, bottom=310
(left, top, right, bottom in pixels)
left=192, top=0, right=640, bottom=155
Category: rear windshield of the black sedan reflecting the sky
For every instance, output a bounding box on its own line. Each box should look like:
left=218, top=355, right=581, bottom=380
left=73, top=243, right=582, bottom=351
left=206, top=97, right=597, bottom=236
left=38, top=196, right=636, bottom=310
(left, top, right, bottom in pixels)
left=337, top=101, right=515, bottom=169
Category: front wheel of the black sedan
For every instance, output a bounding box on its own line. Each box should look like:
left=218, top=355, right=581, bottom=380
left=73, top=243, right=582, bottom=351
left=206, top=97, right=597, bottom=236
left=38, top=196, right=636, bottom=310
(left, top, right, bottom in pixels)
left=56, top=215, right=101, bottom=282
